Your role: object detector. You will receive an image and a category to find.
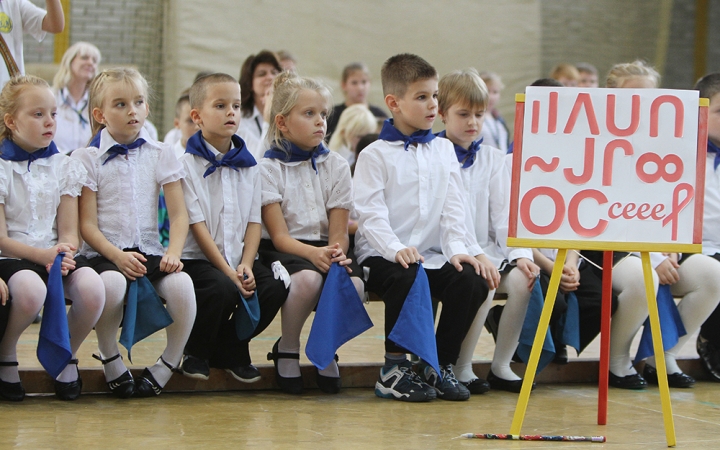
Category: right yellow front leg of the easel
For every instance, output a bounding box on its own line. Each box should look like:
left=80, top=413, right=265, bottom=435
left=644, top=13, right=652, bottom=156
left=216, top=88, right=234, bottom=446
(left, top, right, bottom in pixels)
left=640, top=252, right=675, bottom=447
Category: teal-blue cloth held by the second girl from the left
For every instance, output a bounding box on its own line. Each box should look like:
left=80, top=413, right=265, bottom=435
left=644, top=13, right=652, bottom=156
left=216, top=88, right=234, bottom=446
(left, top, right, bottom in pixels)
left=120, top=277, right=173, bottom=362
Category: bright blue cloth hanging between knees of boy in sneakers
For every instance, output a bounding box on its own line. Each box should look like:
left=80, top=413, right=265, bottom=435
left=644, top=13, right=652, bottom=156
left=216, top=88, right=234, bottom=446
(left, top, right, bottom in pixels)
left=388, top=263, right=440, bottom=373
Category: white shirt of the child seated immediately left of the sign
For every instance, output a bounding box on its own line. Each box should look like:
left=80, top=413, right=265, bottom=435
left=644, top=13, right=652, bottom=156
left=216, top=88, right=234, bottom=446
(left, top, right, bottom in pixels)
left=459, top=145, right=533, bottom=268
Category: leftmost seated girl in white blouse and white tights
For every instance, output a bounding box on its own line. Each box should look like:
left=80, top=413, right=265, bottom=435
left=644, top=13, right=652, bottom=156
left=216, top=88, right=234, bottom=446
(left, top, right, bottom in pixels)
left=0, top=76, right=105, bottom=401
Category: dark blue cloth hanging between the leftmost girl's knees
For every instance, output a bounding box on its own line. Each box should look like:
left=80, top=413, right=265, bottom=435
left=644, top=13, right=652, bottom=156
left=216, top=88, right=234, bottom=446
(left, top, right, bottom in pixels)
left=37, top=253, right=72, bottom=379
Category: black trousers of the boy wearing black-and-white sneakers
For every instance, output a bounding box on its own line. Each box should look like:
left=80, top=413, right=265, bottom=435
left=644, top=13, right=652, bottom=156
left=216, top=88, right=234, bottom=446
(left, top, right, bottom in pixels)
left=363, top=256, right=489, bottom=365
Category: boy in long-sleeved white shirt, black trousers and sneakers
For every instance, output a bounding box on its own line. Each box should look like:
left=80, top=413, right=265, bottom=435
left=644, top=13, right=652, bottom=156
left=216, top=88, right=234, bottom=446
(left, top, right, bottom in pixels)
left=354, top=54, right=494, bottom=402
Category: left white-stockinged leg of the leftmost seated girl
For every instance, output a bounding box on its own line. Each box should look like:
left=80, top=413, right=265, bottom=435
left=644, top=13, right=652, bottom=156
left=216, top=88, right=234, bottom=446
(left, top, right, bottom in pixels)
left=0, top=270, right=47, bottom=383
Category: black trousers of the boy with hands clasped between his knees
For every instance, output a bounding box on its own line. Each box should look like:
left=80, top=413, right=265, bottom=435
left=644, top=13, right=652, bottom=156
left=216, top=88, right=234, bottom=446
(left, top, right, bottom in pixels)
left=183, top=259, right=288, bottom=369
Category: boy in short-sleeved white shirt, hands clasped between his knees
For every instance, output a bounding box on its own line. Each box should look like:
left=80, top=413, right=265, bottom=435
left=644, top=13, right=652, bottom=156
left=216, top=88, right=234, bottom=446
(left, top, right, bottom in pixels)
left=180, top=74, right=287, bottom=383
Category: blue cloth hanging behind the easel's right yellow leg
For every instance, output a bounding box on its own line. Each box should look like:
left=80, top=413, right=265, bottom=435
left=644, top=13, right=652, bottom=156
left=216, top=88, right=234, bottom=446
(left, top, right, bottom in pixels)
left=635, top=284, right=687, bottom=363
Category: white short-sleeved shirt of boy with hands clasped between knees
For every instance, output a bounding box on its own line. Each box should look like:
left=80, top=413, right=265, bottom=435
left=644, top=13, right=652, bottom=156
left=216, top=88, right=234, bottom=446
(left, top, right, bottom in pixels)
left=180, top=139, right=262, bottom=268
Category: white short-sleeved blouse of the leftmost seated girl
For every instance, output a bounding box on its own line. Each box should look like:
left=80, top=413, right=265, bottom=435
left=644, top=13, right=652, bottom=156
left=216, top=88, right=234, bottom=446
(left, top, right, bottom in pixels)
left=0, top=153, right=87, bottom=255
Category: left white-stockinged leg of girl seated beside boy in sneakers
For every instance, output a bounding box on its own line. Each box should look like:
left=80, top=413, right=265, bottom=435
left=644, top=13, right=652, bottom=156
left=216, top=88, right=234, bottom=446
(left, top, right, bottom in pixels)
left=278, top=270, right=322, bottom=378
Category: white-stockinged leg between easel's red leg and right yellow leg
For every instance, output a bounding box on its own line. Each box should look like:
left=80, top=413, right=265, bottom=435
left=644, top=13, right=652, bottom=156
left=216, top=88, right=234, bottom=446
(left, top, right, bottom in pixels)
left=610, top=256, right=658, bottom=377
